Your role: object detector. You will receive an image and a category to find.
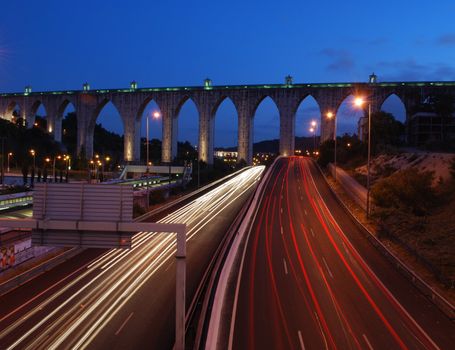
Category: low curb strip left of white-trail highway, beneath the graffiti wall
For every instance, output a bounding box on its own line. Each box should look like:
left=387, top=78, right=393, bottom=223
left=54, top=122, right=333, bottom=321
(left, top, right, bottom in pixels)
left=0, top=248, right=84, bottom=296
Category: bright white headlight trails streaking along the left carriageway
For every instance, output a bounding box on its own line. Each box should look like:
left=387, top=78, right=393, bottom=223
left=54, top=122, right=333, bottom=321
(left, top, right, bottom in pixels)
left=0, top=167, right=264, bottom=349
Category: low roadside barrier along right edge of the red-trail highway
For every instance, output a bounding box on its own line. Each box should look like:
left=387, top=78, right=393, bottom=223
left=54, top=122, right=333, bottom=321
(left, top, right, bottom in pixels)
left=316, top=163, right=455, bottom=321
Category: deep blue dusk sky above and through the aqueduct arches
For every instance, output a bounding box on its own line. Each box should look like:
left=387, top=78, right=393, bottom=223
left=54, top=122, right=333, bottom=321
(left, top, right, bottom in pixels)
left=0, top=0, right=455, bottom=146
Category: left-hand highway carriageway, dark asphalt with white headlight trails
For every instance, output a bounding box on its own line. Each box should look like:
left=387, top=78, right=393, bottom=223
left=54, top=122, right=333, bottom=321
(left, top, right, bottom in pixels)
left=0, top=167, right=264, bottom=349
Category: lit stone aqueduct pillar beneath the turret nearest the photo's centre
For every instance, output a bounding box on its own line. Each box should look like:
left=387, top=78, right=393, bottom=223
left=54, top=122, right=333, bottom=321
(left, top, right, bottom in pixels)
left=198, top=105, right=215, bottom=164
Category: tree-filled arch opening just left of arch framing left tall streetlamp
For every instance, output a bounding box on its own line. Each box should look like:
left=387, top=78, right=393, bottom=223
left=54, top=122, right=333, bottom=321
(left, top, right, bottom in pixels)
left=86, top=100, right=124, bottom=172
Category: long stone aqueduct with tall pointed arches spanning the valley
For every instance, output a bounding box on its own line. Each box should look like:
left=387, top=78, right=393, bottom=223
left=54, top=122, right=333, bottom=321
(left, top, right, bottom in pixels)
left=0, top=74, right=455, bottom=164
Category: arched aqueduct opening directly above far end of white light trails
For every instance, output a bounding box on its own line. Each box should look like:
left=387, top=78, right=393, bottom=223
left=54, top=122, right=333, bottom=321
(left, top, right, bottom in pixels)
left=252, top=96, right=280, bottom=156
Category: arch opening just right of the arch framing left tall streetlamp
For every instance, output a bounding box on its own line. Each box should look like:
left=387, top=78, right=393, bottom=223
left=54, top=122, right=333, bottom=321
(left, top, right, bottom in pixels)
left=174, top=98, right=199, bottom=162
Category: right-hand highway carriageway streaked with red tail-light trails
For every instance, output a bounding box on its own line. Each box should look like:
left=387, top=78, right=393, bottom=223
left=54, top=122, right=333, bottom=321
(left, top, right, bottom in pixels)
left=233, top=157, right=455, bottom=350
